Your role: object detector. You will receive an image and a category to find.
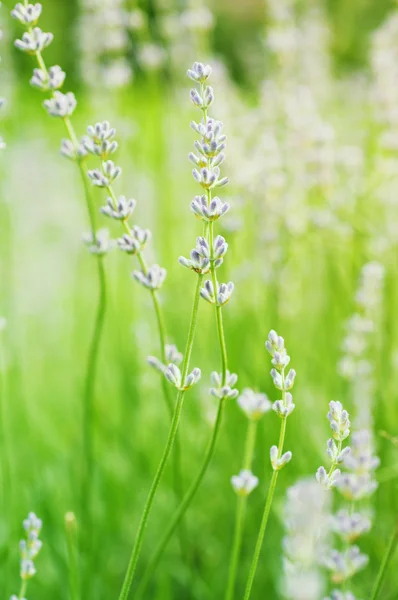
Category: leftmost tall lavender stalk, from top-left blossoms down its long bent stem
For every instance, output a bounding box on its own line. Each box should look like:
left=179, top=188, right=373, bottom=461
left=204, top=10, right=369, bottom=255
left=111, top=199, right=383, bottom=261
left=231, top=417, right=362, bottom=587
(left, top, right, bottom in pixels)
left=11, top=0, right=109, bottom=531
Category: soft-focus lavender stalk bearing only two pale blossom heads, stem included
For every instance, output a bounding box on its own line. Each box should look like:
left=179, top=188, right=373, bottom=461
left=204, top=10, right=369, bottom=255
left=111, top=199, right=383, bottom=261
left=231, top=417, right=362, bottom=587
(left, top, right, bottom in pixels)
left=225, top=388, right=271, bottom=600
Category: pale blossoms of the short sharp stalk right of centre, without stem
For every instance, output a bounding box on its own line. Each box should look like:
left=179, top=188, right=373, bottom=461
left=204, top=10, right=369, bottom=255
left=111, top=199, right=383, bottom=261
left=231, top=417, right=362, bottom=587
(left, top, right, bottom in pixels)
left=265, top=330, right=296, bottom=471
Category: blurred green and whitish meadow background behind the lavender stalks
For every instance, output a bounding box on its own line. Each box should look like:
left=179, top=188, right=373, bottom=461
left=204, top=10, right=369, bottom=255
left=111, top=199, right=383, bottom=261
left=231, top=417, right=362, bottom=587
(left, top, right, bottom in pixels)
left=0, top=0, right=398, bottom=600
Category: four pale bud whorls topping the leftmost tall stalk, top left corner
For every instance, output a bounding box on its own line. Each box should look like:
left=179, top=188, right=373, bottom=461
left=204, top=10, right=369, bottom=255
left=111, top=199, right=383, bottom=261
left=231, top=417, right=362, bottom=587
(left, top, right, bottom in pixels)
left=11, top=2, right=77, bottom=118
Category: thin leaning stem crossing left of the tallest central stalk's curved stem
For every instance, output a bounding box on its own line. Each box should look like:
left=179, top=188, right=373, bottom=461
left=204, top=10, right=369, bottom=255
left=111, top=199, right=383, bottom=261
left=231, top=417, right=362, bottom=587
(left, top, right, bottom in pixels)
left=115, top=275, right=203, bottom=600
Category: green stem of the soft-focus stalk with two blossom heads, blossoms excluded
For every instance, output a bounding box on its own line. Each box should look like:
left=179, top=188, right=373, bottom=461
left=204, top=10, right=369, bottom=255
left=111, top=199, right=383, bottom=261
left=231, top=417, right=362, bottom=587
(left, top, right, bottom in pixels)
left=225, top=420, right=257, bottom=600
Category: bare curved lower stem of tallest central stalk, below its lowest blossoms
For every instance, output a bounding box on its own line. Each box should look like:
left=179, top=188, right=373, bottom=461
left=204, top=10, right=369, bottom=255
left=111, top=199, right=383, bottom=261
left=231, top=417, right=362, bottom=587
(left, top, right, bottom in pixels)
left=136, top=399, right=225, bottom=598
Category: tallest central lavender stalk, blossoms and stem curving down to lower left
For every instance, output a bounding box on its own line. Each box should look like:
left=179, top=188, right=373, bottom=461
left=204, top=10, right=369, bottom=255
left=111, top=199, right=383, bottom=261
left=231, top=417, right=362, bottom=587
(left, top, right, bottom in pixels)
left=137, top=62, right=239, bottom=597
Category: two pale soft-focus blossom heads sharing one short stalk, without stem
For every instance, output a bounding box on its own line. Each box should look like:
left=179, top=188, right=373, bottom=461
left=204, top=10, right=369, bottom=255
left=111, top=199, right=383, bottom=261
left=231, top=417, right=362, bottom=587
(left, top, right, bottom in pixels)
left=231, top=388, right=271, bottom=496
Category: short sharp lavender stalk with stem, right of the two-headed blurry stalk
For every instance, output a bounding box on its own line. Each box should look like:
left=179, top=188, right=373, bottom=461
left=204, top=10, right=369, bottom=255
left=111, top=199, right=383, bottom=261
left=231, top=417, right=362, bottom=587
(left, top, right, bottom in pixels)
left=244, top=330, right=296, bottom=600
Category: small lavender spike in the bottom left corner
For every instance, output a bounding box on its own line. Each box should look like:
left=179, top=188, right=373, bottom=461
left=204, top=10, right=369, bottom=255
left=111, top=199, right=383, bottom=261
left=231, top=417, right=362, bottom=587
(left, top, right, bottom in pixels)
left=10, top=512, right=43, bottom=600
